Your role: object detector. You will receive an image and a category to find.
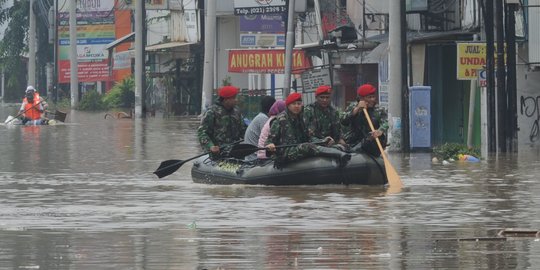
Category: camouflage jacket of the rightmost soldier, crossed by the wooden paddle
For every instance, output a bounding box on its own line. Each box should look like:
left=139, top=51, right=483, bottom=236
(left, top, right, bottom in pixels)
left=341, top=102, right=388, bottom=145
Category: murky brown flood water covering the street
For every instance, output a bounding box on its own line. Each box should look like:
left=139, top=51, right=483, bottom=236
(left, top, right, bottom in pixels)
left=0, top=107, right=540, bottom=269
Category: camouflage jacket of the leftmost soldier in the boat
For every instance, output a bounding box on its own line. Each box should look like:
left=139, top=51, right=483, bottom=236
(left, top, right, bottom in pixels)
left=197, top=101, right=246, bottom=151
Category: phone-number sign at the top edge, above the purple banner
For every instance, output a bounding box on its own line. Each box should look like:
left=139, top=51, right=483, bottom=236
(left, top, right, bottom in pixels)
left=234, top=0, right=287, bottom=15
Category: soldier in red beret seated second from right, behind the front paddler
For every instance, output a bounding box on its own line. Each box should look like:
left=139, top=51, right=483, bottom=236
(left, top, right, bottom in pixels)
left=304, top=85, right=346, bottom=149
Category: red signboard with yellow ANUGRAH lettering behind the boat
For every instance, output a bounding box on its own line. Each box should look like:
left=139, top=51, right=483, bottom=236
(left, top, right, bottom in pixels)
left=229, top=50, right=311, bottom=74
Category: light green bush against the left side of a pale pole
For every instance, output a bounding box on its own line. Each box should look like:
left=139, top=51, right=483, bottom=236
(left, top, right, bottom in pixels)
left=103, top=77, right=135, bottom=108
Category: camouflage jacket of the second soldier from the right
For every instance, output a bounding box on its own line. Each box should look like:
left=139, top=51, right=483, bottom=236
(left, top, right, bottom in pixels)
left=304, top=102, right=342, bottom=142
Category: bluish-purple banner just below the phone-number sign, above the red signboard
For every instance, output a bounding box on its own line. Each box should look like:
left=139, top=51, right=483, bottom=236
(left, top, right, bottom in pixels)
left=240, top=14, right=285, bottom=33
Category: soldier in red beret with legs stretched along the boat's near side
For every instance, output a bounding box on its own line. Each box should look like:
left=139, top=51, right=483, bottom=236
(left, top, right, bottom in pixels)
left=266, top=93, right=351, bottom=167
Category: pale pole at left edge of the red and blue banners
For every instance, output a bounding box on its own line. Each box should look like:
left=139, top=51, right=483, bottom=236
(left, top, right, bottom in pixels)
left=69, top=0, right=79, bottom=108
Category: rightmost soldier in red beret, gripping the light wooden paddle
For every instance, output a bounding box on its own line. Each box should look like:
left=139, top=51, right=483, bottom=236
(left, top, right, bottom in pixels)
left=341, top=84, right=388, bottom=156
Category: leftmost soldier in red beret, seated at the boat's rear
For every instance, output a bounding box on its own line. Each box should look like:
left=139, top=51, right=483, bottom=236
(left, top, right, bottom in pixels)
left=197, top=86, right=246, bottom=158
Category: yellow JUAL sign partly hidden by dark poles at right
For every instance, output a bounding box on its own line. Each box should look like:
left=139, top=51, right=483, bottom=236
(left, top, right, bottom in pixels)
left=457, top=43, right=506, bottom=80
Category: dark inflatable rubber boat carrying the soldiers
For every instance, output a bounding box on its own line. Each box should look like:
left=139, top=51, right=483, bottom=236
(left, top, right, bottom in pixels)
left=191, top=153, right=388, bottom=185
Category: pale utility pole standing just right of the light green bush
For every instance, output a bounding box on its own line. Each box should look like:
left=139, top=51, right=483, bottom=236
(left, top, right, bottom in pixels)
left=135, top=0, right=146, bottom=118
